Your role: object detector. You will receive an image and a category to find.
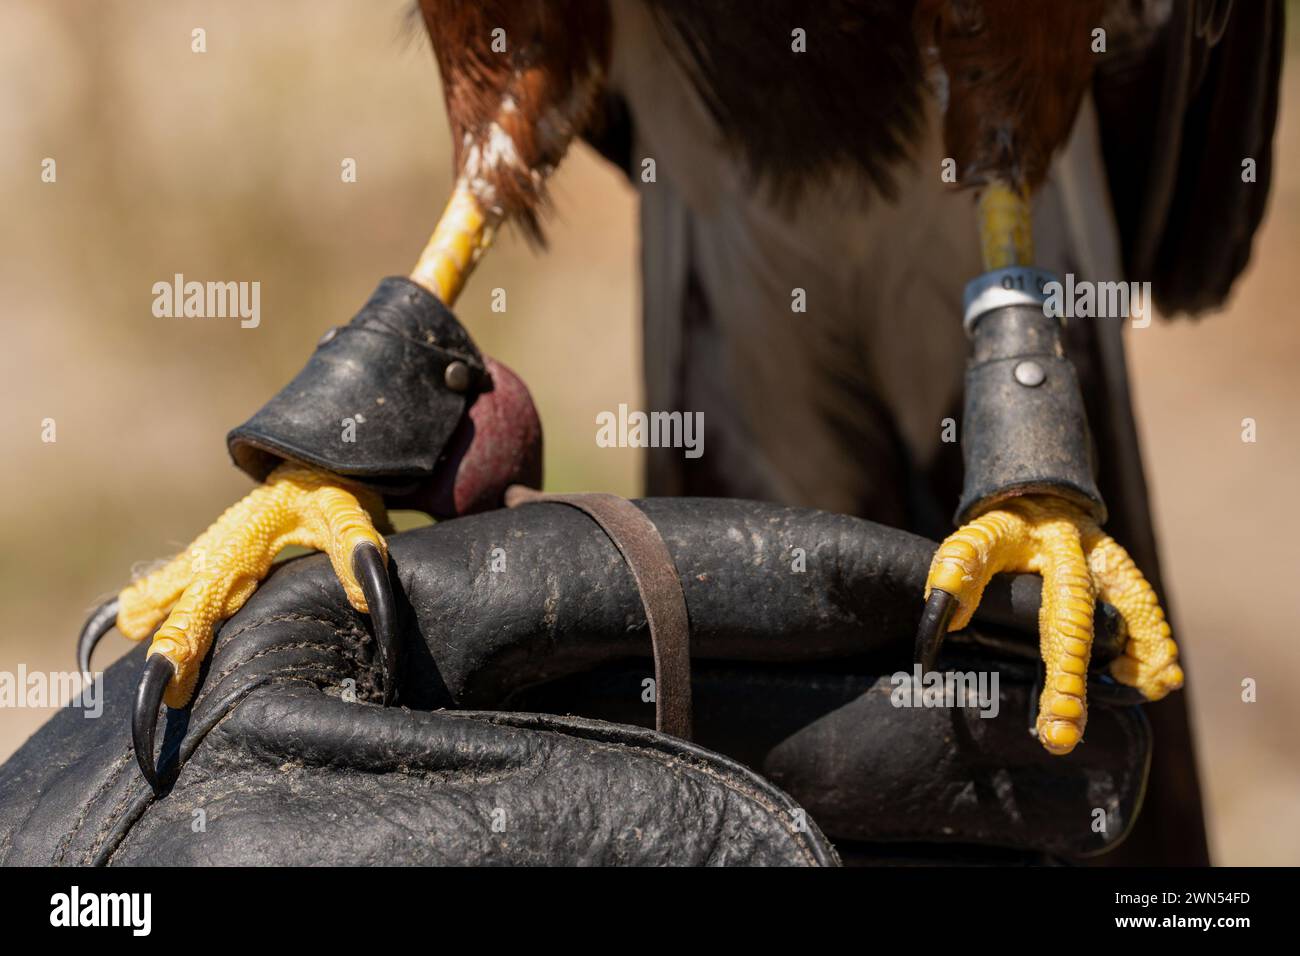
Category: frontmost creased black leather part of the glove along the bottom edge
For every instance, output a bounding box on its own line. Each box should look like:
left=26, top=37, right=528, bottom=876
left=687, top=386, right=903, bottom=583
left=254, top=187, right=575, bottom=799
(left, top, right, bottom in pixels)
left=0, top=653, right=836, bottom=865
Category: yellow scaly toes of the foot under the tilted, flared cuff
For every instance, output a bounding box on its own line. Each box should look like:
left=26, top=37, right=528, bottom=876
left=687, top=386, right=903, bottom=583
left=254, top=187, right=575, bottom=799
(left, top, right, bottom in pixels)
left=117, top=463, right=387, bottom=708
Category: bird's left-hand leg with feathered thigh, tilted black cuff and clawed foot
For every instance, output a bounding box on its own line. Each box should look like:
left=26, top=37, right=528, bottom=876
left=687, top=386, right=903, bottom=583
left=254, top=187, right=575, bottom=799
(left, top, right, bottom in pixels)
left=78, top=0, right=610, bottom=790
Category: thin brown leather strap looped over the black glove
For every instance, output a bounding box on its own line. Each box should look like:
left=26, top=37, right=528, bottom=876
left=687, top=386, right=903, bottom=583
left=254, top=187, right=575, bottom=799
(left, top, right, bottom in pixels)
left=506, top=485, right=690, bottom=740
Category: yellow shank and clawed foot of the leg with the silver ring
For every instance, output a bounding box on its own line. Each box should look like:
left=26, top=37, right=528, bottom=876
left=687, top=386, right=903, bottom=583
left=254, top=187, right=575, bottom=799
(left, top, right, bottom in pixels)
left=917, top=181, right=1183, bottom=754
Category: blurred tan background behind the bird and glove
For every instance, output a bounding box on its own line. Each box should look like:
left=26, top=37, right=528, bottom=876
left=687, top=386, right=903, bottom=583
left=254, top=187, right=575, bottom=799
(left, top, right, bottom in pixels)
left=0, top=0, right=1300, bottom=864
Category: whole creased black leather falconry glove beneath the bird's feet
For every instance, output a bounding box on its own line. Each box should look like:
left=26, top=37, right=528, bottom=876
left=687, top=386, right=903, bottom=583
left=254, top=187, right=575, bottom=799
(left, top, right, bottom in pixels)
left=0, top=499, right=1149, bottom=865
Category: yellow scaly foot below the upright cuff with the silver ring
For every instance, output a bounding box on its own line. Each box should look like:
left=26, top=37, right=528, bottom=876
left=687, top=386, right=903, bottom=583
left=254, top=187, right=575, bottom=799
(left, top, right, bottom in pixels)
left=922, top=496, right=1183, bottom=753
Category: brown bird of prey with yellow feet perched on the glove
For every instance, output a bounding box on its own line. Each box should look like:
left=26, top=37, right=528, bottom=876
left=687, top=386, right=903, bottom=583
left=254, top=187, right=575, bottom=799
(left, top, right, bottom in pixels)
left=82, top=0, right=1282, bottom=860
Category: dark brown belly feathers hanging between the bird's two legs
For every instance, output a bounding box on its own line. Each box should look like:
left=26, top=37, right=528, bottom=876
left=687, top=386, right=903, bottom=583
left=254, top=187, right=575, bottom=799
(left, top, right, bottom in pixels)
left=646, top=0, right=923, bottom=204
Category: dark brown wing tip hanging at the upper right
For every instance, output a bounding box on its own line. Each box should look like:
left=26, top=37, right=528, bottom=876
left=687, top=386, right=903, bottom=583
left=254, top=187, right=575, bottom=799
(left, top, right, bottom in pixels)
left=1095, top=0, right=1284, bottom=316
